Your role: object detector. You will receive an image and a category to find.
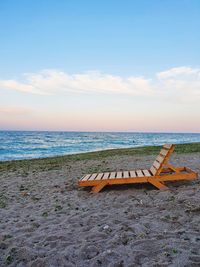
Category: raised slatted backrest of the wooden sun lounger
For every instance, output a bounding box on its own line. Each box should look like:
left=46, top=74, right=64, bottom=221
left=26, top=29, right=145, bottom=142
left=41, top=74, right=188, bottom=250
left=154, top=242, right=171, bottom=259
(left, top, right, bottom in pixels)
left=150, top=144, right=174, bottom=175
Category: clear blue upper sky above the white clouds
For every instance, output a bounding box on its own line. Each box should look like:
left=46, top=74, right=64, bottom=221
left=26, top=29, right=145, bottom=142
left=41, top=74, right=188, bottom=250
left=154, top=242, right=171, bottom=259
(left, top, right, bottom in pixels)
left=0, top=0, right=200, bottom=77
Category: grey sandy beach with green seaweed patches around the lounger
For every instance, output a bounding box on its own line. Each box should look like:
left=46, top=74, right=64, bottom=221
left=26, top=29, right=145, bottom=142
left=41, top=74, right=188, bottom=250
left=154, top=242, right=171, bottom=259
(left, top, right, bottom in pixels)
left=0, top=144, right=200, bottom=267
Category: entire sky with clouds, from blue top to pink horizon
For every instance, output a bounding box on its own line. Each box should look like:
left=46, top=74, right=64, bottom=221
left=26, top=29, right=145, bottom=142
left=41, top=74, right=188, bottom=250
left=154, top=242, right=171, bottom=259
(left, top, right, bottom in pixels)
left=0, top=0, right=200, bottom=132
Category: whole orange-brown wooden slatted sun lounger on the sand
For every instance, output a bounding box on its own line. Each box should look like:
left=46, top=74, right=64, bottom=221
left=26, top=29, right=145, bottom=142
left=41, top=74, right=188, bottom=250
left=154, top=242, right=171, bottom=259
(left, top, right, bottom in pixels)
left=78, top=144, right=198, bottom=193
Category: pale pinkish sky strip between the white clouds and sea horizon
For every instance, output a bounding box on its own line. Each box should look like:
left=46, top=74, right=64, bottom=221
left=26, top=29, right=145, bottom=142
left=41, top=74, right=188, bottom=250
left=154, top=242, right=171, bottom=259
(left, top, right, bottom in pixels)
left=0, top=71, right=200, bottom=132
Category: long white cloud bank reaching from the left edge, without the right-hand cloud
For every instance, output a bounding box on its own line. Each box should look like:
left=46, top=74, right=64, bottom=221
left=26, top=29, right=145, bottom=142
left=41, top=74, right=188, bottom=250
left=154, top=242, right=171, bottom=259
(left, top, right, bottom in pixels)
left=0, top=70, right=153, bottom=95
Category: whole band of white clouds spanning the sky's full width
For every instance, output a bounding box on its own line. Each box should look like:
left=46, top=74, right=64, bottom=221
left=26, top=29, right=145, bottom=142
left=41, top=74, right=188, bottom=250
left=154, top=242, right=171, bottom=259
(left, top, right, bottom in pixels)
left=0, top=66, right=200, bottom=101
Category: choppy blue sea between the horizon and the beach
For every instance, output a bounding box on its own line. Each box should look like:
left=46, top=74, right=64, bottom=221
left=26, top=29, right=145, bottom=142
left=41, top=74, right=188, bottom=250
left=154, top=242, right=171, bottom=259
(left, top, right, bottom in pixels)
left=0, top=131, right=200, bottom=161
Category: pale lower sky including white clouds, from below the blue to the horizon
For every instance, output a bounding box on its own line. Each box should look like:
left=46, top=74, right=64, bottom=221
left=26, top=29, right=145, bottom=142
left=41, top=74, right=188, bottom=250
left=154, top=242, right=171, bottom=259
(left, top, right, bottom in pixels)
left=0, top=67, right=200, bottom=132
